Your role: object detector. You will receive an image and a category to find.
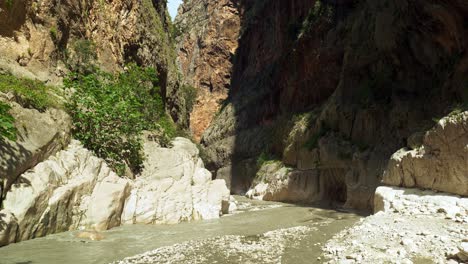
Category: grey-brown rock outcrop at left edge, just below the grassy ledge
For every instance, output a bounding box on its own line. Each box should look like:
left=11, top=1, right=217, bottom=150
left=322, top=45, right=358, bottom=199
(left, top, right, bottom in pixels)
left=0, top=93, right=71, bottom=204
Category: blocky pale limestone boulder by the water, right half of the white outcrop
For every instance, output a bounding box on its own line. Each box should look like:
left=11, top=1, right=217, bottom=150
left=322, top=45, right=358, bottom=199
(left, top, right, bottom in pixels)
left=122, top=138, right=229, bottom=224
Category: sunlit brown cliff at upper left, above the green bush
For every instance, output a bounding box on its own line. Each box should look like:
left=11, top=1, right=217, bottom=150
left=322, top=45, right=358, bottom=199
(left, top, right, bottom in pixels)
left=0, top=0, right=188, bottom=126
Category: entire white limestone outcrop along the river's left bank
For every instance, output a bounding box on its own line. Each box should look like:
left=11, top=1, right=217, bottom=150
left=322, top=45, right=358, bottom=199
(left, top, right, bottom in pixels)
left=0, top=138, right=230, bottom=246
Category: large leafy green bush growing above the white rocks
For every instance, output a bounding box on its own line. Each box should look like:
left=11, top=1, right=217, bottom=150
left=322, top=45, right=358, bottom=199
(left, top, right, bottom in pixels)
left=64, top=64, right=175, bottom=175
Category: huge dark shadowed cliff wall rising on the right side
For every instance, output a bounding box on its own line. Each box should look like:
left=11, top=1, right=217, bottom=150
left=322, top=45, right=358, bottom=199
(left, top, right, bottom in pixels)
left=202, top=0, right=468, bottom=208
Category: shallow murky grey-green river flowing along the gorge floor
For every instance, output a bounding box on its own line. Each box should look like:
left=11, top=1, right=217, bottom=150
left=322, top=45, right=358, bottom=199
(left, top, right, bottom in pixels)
left=0, top=197, right=360, bottom=264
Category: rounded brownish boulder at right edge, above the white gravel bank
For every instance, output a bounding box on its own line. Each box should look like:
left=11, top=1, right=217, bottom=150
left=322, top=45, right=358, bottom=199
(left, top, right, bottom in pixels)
left=383, top=112, right=468, bottom=196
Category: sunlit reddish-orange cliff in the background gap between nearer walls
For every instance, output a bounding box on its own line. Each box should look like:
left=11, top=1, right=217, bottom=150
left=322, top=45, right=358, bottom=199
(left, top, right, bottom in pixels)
left=175, top=0, right=240, bottom=140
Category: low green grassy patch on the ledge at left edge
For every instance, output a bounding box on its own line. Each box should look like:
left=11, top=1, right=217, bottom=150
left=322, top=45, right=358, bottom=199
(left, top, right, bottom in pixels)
left=0, top=74, right=59, bottom=111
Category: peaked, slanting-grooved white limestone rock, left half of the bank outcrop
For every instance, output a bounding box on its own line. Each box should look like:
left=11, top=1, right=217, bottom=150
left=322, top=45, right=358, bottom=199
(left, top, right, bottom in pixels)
left=3, top=141, right=124, bottom=241
